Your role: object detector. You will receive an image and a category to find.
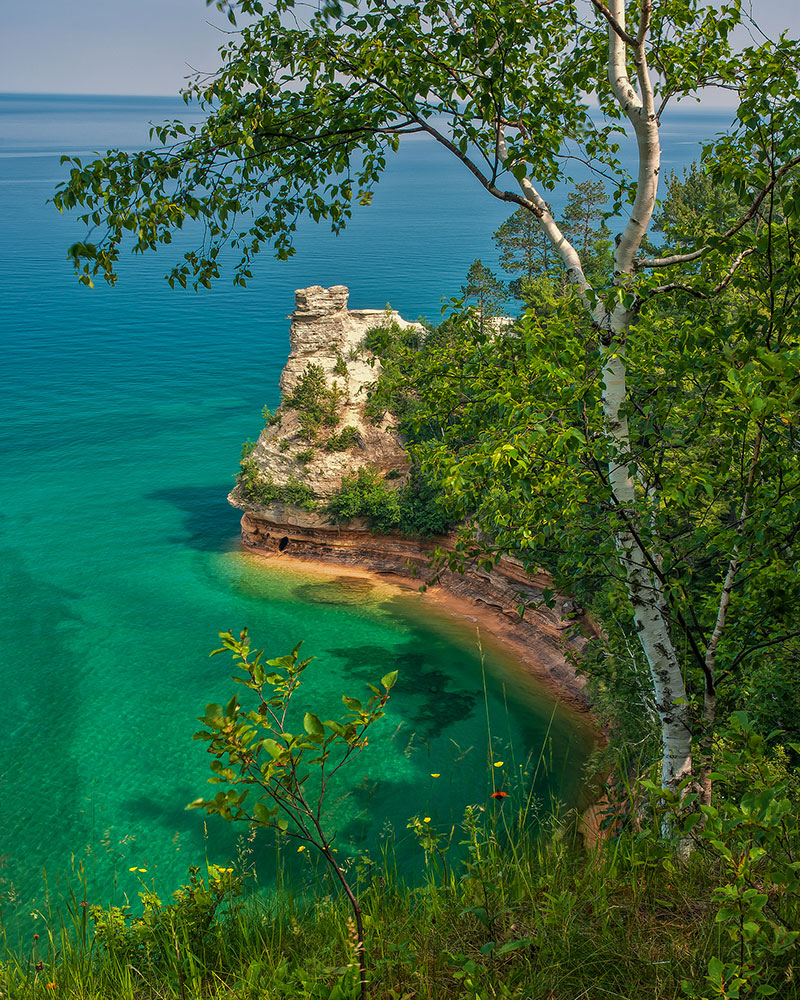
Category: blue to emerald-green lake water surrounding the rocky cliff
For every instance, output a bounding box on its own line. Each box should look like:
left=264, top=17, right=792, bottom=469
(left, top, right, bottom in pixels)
left=0, top=96, right=728, bottom=928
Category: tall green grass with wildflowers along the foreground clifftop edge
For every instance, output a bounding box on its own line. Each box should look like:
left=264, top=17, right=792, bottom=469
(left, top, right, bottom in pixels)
left=0, top=788, right=800, bottom=1000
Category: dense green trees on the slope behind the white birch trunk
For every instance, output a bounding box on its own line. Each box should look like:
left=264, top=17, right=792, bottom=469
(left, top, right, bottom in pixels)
left=370, top=154, right=800, bottom=754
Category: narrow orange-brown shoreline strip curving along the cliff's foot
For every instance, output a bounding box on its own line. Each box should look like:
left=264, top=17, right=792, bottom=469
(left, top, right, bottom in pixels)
left=234, top=542, right=603, bottom=742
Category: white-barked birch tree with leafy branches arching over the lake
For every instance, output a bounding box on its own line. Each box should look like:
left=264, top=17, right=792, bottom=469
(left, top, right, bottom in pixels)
left=55, top=0, right=800, bottom=787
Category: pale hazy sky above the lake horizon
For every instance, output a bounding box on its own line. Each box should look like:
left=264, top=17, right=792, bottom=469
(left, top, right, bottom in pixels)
left=0, top=0, right=800, bottom=95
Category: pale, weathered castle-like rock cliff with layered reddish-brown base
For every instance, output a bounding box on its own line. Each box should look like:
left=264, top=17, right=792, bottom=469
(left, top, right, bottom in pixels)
left=229, top=285, right=585, bottom=705
